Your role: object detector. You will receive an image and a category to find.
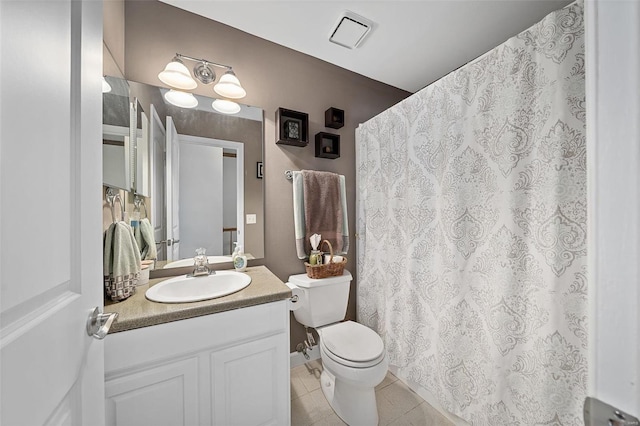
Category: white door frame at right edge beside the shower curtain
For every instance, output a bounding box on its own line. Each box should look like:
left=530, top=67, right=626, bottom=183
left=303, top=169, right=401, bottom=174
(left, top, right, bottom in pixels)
left=585, top=0, right=640, bottom=424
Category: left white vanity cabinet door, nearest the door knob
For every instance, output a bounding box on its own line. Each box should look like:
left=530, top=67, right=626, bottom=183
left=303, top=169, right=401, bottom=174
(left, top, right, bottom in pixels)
left=105, top=358, right=201, bottom=426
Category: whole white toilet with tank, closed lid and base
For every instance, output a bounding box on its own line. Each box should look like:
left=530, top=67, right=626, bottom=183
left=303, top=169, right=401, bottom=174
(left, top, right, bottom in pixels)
left=287, top=271, right=389, bottom=426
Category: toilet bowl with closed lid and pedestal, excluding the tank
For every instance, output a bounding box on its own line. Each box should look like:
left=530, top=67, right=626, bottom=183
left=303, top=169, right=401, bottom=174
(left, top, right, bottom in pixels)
left=318, top=321, right=389, bottom=426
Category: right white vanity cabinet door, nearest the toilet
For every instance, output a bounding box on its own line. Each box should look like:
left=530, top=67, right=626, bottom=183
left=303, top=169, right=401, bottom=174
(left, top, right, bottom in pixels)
left=211, top=334, right=290, bottom=426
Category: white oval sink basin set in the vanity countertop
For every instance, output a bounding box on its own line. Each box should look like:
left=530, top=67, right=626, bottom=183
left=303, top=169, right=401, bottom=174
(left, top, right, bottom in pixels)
left=145, top=271, right=251, bottom=303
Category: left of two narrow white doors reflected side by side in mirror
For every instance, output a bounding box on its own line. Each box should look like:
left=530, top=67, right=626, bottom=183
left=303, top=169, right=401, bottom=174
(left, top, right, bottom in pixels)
left=149, top=104, right=167, bottom=260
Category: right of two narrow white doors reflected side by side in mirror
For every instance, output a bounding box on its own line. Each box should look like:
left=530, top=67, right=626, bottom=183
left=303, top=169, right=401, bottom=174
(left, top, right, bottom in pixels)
left=165, top=117, right=180, bottom=261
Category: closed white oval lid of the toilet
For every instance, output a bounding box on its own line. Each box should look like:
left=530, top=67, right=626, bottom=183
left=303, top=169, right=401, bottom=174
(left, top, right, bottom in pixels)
left=320, top=321, right=384, bottom=362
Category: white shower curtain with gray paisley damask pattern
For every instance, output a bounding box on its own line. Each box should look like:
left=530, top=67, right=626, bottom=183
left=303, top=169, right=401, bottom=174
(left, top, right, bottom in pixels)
left=356, top=3, right=588, bottom=426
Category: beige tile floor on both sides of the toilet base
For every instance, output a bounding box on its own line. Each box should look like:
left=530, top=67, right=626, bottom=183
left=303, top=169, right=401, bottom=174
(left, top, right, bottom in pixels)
left=291, top=360, right=453, bottom=426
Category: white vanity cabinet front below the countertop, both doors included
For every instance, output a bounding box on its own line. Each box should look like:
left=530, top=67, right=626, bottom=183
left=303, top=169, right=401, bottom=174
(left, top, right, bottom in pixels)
left=105, top=300, right=290, bottom=426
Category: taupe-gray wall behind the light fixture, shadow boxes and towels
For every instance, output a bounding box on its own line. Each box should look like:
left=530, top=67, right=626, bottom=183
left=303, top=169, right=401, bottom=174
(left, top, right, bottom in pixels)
left=120, top=1, right=409, bottom=350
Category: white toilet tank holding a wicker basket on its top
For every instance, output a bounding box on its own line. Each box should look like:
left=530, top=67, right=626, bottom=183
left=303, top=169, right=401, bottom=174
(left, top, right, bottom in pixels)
left=289, top=271, right=352, bottom=327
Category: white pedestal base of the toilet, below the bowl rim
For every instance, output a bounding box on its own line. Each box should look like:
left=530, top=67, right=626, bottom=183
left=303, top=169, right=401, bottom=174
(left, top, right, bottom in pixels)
left=320, top=368, right=378, bottom=426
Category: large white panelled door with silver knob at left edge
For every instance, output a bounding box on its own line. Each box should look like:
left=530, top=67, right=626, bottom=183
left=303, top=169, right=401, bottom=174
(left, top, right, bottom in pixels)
left=0, top=0, right=104, bottom=425
